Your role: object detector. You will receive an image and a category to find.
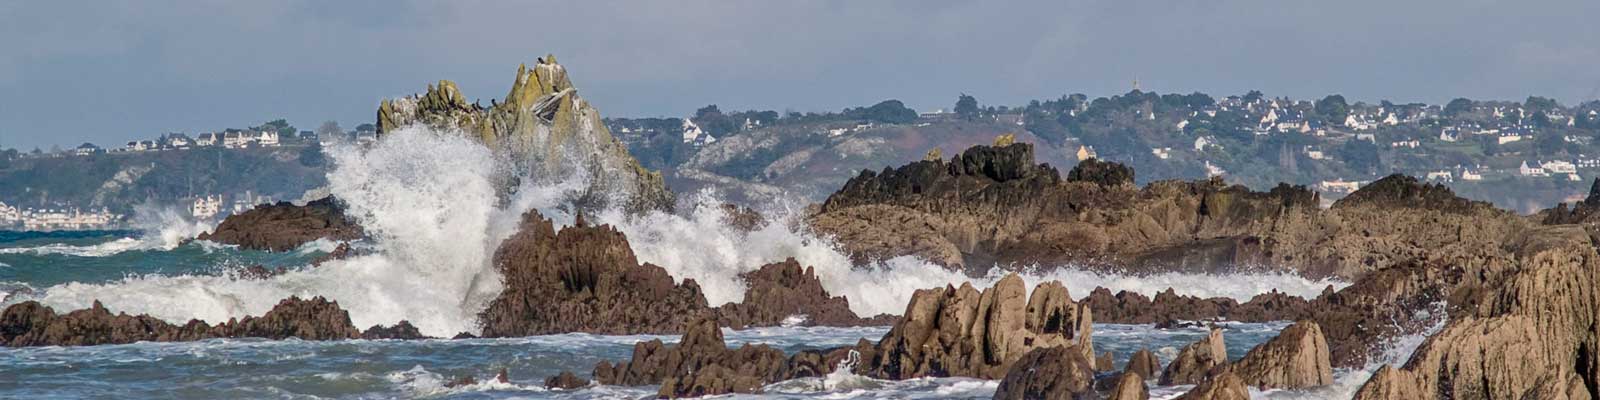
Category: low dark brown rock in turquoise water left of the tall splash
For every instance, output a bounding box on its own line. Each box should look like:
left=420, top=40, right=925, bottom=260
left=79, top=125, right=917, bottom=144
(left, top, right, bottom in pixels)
left=195, top=197, right=363, bottom=251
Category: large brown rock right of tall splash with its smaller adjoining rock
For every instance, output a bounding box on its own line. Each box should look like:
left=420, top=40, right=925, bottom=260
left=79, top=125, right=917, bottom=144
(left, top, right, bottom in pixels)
left=478, top=211, right=893, bottom=338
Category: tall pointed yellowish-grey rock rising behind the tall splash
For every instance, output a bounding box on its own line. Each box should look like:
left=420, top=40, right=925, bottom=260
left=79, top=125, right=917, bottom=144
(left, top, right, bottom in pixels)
left=378, top=56, right=675, bottom=216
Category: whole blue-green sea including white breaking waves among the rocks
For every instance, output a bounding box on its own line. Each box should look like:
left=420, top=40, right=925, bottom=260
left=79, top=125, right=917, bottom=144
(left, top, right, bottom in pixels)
left=0, top=128, right=1426, bottom=398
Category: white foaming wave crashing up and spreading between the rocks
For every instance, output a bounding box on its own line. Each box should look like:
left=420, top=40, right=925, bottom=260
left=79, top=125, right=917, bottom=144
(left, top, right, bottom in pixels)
left=18, top=128, right=1342, bottom=338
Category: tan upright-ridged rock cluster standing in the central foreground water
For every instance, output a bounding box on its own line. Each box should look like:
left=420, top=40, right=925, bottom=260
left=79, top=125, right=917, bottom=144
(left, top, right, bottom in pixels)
left=862, top=274, right=1094, bottom=379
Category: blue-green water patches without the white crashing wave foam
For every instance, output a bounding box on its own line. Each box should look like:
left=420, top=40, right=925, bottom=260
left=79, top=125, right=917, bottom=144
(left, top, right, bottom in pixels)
left=0, top=230, right=1376, bottom=398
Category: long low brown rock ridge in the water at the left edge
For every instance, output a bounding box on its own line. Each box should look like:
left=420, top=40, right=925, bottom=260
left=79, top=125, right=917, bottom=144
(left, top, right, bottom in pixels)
left=0, top=298, right=374, bottom=347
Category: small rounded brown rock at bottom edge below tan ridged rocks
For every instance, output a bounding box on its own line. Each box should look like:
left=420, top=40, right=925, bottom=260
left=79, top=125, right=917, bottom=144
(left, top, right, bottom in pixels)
left=994, top=346, right=1094, bottom=400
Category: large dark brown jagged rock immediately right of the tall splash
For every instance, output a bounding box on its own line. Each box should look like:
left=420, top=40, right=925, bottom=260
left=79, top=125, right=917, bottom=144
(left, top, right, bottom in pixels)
left=478, top=211, right=710, bottom=338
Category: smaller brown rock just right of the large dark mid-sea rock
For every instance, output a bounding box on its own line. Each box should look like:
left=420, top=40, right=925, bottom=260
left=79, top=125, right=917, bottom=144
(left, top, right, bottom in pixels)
left=717, top=258, right=891, bottom=328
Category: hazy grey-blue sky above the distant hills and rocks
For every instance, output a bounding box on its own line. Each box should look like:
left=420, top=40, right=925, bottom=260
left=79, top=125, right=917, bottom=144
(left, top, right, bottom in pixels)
left=0, top=0, right=1600, bottom=149
